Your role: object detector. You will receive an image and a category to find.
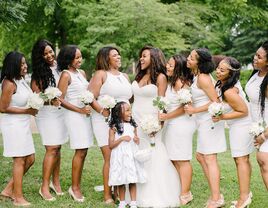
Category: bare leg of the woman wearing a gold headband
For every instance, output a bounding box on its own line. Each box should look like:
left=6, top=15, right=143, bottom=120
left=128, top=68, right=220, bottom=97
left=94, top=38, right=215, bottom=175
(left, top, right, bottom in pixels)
left=234, top=155, right=251, bottom=207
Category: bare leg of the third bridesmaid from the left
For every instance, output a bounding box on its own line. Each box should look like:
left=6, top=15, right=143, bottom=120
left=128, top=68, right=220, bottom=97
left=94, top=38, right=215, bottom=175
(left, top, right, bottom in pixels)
left=72, top=149, right=87, bottom=199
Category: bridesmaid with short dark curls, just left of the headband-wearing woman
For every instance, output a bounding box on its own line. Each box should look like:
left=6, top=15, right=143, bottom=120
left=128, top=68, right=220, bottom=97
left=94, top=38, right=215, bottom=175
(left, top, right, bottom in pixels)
left=184, top=48, right=226, bottom=208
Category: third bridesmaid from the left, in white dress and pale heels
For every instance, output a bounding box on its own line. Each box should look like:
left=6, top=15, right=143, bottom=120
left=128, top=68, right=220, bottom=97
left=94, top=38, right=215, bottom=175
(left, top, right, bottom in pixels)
left=57, top=45, right=93, bottom=202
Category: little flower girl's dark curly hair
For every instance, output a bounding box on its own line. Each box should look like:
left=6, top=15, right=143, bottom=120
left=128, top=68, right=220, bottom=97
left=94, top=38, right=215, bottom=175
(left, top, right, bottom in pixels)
left=109, top=101, right=137, bottom=135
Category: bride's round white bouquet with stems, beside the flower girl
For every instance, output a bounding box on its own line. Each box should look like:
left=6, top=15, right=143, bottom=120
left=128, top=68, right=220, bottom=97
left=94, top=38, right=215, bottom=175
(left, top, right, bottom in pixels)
left=140, top=115, right=161, bottom=147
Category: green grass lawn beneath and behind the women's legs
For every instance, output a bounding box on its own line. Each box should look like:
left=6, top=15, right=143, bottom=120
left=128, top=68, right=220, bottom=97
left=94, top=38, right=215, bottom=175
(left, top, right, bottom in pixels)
left=0, top=134, right=268, bottom=208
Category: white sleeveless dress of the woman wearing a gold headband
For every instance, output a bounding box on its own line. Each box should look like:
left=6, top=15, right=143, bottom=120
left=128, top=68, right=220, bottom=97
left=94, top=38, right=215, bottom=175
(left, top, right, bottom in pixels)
left=218, top=81, right=254, bottom=157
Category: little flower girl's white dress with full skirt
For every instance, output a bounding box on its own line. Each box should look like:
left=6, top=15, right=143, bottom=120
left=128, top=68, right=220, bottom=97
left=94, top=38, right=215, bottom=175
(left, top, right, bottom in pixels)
left=109, top=123, right=146, bottom=186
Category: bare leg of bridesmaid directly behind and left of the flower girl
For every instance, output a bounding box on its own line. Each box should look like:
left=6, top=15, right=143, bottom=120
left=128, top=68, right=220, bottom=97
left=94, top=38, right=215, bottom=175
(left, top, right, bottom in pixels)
left=101, top=145, right=112, bottom=201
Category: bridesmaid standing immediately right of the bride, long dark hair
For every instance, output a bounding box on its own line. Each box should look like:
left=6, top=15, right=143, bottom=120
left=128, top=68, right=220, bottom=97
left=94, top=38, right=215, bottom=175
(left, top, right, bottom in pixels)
left=159, top=55, right=195, bottom=205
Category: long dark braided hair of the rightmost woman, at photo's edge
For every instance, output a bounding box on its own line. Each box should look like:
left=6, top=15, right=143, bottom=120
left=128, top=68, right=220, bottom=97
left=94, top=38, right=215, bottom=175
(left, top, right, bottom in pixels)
left=259, top=41, right=268, bottom=117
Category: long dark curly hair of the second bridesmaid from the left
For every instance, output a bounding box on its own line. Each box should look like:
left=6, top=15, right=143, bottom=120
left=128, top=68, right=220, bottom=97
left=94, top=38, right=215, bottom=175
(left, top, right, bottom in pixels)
left=32, top=40, right=56, bottom=91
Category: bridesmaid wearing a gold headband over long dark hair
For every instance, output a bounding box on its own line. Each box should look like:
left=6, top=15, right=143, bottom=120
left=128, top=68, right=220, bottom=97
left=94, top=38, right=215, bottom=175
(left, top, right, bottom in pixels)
left=213, top=57, right=254, bottom=208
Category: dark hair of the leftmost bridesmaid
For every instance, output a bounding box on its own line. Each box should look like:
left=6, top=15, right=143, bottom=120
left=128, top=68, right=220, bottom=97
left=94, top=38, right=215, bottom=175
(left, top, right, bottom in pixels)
left=0, top=51, right=24, bottom=82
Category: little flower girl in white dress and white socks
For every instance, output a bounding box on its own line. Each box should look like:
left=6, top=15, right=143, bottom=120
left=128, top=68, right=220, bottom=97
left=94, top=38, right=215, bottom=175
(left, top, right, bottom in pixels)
left=109, top=102, right=145, bottom=208
